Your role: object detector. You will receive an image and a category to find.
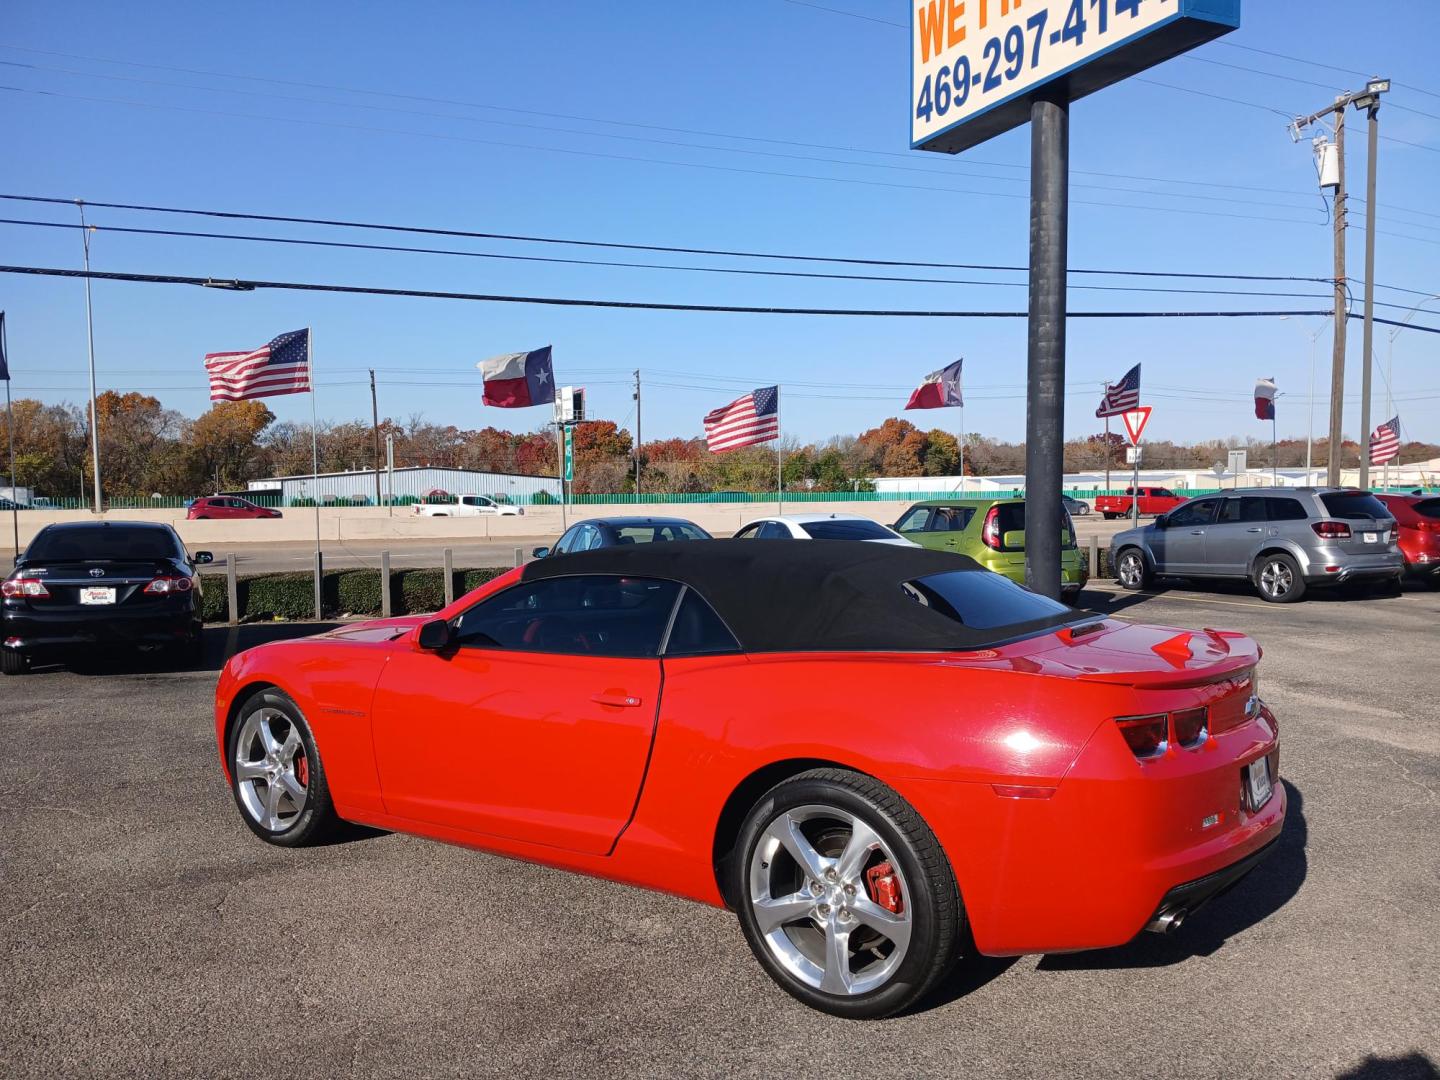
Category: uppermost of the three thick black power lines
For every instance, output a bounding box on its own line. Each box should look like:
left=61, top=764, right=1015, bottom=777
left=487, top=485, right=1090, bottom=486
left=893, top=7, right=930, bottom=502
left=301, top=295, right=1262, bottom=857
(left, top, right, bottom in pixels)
left=0, top=194, right=1333, bottom=285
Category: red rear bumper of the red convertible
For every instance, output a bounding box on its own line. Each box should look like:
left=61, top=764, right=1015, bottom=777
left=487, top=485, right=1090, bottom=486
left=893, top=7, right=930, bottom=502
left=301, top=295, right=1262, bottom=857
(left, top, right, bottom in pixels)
left=903, top=708, right=1286, bottom=956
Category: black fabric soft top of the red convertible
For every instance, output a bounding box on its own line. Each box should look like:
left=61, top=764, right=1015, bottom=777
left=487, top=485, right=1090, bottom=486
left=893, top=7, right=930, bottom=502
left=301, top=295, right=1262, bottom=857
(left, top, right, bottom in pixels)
left=521, top=540, right=1080, bottom=652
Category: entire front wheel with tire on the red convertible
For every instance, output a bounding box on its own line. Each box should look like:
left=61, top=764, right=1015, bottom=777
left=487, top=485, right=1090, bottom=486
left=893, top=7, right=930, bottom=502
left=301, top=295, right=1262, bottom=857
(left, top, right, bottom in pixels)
left=226, top=687, right=340, bottom=848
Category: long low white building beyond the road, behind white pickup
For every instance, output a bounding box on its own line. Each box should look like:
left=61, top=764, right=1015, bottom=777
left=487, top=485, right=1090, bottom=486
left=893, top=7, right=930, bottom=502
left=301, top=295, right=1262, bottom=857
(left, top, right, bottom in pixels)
left=246, top=465, right=560, bottom=507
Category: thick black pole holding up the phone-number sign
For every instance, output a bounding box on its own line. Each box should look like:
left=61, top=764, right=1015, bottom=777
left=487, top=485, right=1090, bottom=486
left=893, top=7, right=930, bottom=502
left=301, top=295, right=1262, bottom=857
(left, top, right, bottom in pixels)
left=1025, top=86, right=1070, bottom=600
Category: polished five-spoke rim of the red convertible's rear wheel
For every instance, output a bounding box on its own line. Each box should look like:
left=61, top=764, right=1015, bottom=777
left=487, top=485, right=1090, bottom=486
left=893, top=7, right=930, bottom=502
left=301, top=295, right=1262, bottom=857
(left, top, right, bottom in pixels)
left=749, top=805, right=913, bottom=996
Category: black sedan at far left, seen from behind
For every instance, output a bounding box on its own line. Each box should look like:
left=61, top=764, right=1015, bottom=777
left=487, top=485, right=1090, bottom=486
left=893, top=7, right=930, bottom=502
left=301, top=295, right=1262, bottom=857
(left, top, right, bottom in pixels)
left=0, top=521, right=213, bottom=675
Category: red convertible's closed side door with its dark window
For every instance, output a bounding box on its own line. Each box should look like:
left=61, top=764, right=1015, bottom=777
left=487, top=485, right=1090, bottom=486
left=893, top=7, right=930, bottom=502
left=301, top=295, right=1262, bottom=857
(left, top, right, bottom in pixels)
left=373, top=575, right=680, bottom=855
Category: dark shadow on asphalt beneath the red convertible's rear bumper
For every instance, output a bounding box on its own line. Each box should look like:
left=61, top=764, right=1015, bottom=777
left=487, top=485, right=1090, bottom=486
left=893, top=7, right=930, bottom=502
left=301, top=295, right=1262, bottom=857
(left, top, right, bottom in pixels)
left=1037, top=780, right=1309, bottom=971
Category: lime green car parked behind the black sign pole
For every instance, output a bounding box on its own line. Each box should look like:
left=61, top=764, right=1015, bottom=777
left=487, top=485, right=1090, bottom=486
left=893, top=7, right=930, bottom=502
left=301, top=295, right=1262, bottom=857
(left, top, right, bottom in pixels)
left=894, top=498, right=1090, bottom=603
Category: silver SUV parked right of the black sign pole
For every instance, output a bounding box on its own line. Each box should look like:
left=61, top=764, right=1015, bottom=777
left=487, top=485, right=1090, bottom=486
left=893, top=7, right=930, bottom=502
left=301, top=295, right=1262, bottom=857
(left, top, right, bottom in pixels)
left=1110, top=488, right=1405, bottom=603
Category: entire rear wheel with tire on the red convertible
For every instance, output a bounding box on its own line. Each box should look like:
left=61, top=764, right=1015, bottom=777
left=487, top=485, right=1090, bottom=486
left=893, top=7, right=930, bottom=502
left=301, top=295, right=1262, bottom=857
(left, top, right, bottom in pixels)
left=730, top=769, right=965, bottom=1020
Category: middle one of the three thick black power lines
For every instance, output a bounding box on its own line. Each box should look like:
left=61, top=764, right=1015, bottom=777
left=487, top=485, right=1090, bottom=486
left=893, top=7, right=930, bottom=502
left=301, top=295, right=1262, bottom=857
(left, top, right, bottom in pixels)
left=0, top=217, right=1347, bottom=307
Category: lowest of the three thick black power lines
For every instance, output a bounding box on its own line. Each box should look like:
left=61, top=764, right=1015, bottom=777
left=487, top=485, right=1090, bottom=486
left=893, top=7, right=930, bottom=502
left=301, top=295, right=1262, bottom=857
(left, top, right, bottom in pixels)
left=0, top=266, right=1347, bottom=321
